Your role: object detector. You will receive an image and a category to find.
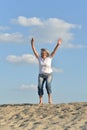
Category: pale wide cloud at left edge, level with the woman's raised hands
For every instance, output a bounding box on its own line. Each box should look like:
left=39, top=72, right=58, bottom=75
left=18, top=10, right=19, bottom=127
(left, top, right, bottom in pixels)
left=0, top=33, right=24, bottom=43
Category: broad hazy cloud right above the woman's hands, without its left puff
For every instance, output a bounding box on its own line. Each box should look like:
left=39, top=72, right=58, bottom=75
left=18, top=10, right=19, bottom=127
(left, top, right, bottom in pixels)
left=30, top=18, right=78, bottom=43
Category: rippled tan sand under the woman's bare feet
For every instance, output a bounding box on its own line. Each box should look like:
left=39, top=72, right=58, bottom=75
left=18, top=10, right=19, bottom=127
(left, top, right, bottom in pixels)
left=0, top=102, right=87, bottom=130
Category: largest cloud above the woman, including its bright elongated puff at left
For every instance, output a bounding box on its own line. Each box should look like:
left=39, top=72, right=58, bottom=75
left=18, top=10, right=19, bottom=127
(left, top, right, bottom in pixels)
left=12, top=16, right=81, bottom=43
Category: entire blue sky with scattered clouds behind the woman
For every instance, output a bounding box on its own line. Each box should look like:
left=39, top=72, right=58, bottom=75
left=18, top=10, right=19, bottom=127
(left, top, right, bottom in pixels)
left=0, top=0, right=87, bottom=104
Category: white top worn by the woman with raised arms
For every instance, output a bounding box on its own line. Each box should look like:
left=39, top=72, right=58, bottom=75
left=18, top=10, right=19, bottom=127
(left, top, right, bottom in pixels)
left=38, top=56, right=52, bottom=74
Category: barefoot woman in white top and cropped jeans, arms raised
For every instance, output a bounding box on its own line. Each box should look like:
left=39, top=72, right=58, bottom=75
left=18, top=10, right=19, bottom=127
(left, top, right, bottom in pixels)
left=31, top=38, right=62, bottom=104
